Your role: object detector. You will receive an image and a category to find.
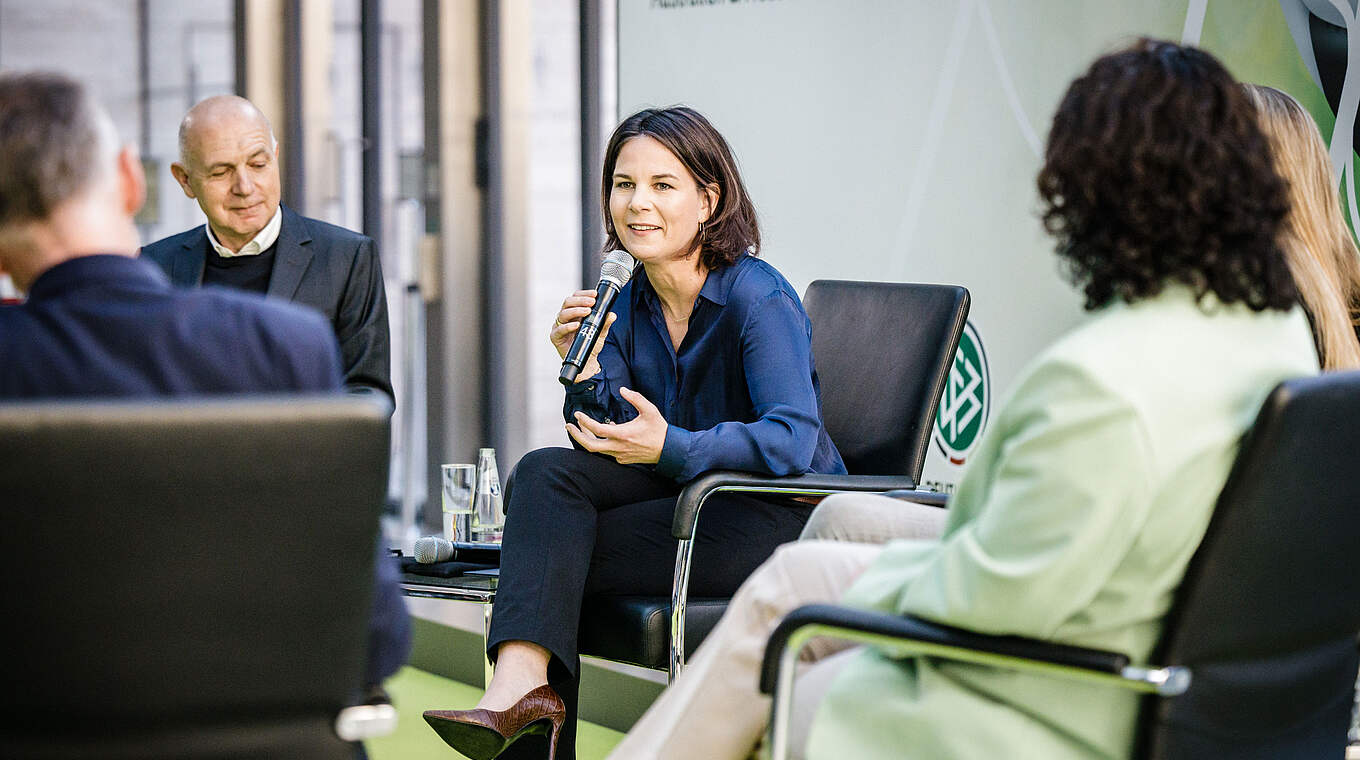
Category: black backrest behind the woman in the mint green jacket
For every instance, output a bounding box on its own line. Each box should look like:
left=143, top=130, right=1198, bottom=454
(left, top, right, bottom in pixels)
left=1140, top=373, right=1360, bottom=760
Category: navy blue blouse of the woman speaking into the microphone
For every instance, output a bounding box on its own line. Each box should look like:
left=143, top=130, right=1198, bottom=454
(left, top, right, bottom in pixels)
left=563, top=254, right=846, bottom=483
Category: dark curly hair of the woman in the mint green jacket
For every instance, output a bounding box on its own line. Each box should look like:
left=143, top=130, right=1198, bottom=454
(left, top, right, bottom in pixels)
left=1038, top=39, right=1296, bottom=311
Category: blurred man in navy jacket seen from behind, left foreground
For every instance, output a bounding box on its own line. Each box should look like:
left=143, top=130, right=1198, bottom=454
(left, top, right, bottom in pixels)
left=0, top=73, right=409, bottom=701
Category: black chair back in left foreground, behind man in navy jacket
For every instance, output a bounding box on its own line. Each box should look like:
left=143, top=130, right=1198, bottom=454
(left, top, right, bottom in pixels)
left=0, top=396, right=394, bottom=759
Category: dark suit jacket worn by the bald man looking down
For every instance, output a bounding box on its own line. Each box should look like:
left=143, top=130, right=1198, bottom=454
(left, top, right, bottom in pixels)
left=141, top=205, right=394, bottom=398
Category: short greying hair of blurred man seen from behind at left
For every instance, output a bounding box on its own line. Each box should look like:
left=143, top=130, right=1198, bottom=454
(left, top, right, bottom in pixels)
left=0, top=72, right=118, bottom=228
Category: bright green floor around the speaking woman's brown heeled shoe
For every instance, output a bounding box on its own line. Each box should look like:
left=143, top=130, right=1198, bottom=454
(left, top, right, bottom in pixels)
left=364, top=668, right=623, bottom=760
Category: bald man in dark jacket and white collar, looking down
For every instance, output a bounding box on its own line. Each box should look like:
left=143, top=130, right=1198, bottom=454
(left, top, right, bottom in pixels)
left=141, top=95, right=393, bottom=400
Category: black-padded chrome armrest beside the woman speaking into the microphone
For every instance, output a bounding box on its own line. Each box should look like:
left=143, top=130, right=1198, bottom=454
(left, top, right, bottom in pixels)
left=670, top=470, right=917, bottom=540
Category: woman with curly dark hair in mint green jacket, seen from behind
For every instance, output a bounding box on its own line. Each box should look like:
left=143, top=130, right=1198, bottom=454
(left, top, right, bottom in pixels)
left=611, top=39, right=1318, bottom=760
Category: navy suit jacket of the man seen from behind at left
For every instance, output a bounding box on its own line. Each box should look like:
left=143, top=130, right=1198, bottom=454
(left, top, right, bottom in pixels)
left=0, top=256, right=411, bottom=684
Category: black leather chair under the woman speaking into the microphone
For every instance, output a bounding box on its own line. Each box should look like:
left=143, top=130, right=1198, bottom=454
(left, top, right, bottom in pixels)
left=579, top=280, right=968, bottom=678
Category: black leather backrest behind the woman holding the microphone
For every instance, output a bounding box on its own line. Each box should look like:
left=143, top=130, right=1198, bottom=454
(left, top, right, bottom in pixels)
left=804, top=280, right=968, bottom=481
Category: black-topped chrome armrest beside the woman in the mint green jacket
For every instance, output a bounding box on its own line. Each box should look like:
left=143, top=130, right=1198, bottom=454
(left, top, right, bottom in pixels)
left=760, top=604, right=1190, bottom=695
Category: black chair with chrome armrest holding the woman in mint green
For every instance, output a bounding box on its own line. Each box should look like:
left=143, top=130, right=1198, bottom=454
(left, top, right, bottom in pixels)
left=760, top=373, right=1360, bottom=760
